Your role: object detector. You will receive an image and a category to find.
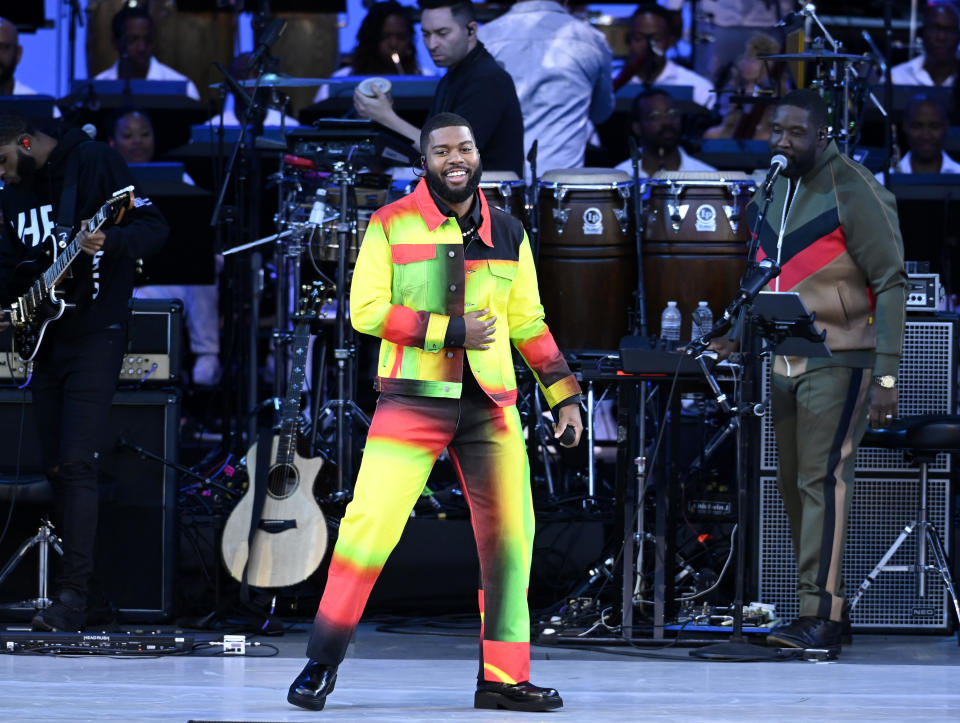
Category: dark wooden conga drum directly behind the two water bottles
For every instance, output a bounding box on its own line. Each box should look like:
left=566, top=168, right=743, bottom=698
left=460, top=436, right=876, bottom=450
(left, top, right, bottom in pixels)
left=643, top=171, right=756, bottom=339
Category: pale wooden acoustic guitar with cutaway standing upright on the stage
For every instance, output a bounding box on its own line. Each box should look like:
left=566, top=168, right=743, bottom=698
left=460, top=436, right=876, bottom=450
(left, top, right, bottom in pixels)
left=221, top=284, right=327, bottom=588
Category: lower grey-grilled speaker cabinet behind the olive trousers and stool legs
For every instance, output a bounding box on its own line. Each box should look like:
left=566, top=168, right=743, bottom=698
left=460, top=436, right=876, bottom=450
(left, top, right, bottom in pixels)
left=758, top=470, right=952, bottom=631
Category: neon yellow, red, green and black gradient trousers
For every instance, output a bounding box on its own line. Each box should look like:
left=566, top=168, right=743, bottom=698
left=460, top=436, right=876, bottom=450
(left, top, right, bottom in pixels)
left=307, top=369, right=534, bottom=683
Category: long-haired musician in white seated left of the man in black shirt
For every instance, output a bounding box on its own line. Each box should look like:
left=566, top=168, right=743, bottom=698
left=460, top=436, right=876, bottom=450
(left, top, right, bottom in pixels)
left=313, top=0, right=428, bottom=103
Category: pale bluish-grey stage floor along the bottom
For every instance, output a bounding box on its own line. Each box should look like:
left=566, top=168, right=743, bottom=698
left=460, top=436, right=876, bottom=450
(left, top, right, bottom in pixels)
left=0, top=624, right=960, bottom=723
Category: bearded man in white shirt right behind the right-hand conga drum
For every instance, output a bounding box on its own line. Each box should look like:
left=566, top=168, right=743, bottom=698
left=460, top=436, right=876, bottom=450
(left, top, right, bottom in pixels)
left=617, top=88, right=717, bottom=178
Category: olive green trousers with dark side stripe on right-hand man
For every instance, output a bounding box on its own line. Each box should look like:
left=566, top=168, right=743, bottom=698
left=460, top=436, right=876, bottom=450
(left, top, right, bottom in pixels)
left=772, top=367, right=872, bottom=621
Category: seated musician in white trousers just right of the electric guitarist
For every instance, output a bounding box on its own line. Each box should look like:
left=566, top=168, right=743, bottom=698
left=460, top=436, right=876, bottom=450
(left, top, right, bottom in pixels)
left=109, top=108, right=220, bottom=386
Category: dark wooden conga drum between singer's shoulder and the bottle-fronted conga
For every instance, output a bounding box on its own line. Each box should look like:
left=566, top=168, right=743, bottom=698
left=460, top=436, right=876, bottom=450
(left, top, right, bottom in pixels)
left=537, top=168, right=637, bottom=350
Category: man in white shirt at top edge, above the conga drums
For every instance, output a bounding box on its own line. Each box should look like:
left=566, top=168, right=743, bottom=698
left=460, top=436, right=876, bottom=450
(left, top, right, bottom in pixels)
left=613, top=2, right=717, bottom=109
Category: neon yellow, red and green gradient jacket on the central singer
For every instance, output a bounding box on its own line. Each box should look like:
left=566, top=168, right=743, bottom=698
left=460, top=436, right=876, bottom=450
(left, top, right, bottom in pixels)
left=350, top=182, right=580, bottom=407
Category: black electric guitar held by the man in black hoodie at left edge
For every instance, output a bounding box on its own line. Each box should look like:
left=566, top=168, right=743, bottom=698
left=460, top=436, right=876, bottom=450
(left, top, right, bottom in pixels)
left=10, top=186, right=134, bottom=362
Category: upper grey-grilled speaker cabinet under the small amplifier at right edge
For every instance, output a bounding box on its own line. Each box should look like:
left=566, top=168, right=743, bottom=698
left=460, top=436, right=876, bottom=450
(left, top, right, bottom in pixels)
left=760, top=317, right=957, bottom=475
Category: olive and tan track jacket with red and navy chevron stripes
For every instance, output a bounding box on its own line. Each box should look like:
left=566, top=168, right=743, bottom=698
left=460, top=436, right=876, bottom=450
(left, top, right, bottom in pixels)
left=747, top=141, right=907, bottom=376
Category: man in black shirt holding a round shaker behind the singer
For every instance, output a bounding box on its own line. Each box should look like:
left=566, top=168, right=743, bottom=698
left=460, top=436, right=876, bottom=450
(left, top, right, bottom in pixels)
left=353, top=0, right=523, bottom=177
